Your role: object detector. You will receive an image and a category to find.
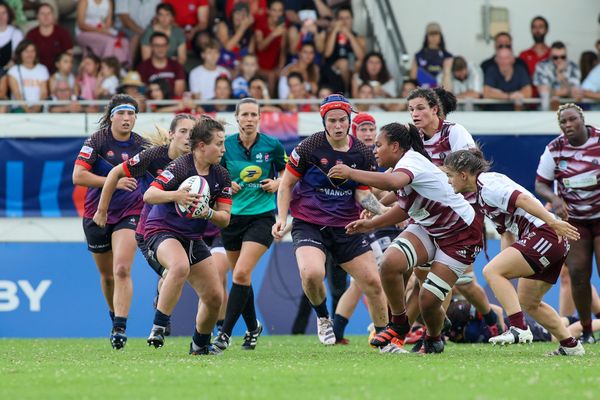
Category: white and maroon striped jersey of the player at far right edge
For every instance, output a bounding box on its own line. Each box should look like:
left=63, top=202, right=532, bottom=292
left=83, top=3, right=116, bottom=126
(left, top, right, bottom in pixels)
left=537, top=126, right=600, bottom=221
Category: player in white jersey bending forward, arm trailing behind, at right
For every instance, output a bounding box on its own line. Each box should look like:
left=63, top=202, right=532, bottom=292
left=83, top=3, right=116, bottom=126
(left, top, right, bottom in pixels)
left=444, top=149, right=585, bottom=355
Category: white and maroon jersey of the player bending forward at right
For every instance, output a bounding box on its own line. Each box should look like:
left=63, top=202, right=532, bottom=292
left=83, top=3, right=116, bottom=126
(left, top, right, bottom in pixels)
left=477, top=172, right=544, bottom=238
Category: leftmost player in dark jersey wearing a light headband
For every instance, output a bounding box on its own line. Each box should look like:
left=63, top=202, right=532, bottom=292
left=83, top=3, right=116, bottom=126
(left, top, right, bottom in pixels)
left=73, top=94, right=147, bottom=350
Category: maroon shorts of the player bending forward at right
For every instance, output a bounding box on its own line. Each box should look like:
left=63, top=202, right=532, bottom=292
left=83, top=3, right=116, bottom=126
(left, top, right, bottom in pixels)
left=511, top=225, right=569, bottom=285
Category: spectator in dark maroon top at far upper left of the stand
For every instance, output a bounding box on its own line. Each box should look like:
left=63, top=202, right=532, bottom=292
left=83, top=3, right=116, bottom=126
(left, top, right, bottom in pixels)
left=25, top=3, right=73, bottom=74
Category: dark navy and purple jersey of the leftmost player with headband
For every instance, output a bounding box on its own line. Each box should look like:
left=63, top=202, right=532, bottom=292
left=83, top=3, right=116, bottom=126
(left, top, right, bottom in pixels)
left=75, top=128, right=147, bottom=224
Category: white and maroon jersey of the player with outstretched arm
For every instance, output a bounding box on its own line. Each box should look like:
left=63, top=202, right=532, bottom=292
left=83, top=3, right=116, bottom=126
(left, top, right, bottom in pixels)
left=394, top=150, right=475, bottom=238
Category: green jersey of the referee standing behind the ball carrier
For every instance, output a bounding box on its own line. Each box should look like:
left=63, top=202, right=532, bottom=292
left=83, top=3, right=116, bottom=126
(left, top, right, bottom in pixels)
left=221, top=133, right=287, bottom=215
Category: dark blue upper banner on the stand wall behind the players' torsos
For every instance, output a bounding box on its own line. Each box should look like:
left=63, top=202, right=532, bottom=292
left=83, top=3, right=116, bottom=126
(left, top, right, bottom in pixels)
left=0, top=135, right=554, bottom=217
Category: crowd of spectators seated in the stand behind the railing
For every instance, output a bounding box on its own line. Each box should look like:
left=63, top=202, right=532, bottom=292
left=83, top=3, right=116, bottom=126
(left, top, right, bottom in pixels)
left=0, top=0, right=600, bottom=112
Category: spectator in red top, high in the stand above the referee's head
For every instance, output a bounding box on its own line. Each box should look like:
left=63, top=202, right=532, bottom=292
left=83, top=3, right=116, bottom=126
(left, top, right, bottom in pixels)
left=255, top=0, right=287, bottom=93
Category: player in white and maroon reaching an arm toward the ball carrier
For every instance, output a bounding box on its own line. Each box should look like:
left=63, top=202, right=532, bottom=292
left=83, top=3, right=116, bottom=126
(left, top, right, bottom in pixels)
left=329, top=123, right=482, bottom=353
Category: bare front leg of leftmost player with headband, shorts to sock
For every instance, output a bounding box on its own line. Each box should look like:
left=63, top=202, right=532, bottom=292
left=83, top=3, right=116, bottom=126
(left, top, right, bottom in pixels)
left=112, top=229, right=137, bottom=317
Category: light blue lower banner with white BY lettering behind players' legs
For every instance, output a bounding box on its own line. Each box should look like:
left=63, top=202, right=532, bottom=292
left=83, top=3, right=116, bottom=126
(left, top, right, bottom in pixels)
left=0, top=240, right=600, bottom=338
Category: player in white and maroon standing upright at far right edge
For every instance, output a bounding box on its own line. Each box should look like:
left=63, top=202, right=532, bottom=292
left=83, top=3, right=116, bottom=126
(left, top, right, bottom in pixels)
left=535, top=104, right=600, bottom=343
